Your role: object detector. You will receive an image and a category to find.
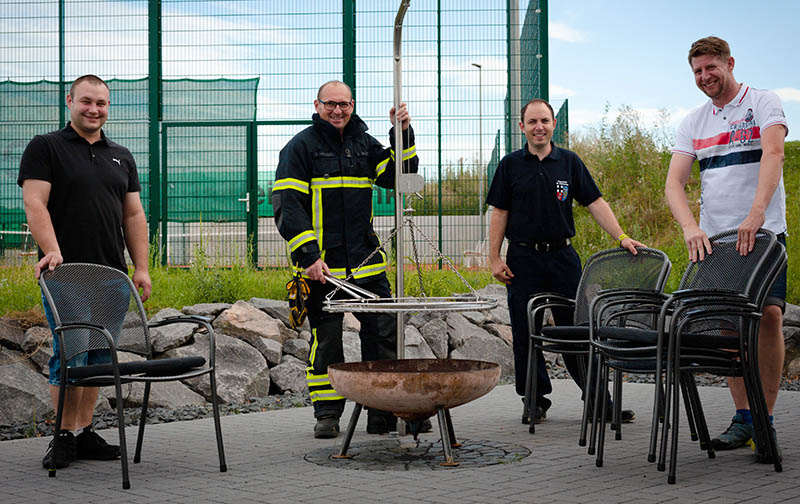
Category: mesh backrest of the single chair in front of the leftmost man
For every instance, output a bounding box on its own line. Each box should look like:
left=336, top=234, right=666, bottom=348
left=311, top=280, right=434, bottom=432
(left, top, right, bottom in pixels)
left=39, top=263, right=151, bottom=359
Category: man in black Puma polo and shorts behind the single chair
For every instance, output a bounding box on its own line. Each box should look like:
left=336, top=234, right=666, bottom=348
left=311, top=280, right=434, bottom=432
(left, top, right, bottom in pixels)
left=17, top=75, right=151, bottom=468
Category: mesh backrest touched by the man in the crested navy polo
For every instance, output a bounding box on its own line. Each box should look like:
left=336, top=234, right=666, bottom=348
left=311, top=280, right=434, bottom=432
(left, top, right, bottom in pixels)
left=575, top=247, right=672, bottom=326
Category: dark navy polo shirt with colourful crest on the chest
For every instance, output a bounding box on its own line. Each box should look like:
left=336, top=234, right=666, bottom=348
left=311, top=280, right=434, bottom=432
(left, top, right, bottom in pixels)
left=486, top=143, right=602, bottom=242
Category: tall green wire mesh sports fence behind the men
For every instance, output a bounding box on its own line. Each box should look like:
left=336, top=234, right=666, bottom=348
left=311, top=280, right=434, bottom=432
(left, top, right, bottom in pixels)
left=0, top=0, right=568, bottom=265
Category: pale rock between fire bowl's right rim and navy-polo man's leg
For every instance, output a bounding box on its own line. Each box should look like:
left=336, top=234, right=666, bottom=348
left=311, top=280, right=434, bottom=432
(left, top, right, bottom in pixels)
left=447, top=313, right=514, bottom=376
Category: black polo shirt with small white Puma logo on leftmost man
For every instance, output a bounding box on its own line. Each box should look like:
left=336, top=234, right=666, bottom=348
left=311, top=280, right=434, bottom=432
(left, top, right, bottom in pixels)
left=17, top=123, right=141, bottom=272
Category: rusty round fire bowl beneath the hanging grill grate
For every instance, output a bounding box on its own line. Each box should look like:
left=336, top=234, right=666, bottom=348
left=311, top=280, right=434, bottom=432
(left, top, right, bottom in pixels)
left=328, top=359, right=500, bottom=421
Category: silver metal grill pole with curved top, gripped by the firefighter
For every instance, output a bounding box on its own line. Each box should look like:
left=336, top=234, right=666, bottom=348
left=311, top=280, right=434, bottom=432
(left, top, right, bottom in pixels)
left=394, top=0, right=411, bottom=359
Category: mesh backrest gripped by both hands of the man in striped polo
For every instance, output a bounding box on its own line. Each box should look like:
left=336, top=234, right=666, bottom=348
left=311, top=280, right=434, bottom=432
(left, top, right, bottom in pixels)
left=679, top=229, right=778, bottom=302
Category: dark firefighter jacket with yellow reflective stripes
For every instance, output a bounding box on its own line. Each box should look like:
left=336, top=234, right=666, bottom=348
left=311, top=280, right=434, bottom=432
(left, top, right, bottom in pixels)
left=272, top=114, right=419, bottom=282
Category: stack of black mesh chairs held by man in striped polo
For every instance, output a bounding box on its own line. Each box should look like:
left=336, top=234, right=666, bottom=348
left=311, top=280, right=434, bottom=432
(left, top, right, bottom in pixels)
left=592, top=230, right=786, bottom=483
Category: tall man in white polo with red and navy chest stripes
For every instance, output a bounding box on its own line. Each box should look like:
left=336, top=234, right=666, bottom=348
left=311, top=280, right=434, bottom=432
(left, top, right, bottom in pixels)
left=665, top=37, right=789, bottom=456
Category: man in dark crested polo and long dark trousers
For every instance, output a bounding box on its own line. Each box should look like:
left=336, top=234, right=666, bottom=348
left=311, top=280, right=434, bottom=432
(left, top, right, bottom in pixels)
left=486, top=99, right=643, bottom=423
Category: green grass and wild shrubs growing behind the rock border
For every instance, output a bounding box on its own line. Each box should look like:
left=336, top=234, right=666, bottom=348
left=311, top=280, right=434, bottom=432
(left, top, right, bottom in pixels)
left=0, top=107, right=800, bottom=316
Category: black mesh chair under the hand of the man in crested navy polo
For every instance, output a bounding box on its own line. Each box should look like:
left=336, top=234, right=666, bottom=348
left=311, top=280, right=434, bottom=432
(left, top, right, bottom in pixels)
left=523, top=248, right=671, bottom=436
